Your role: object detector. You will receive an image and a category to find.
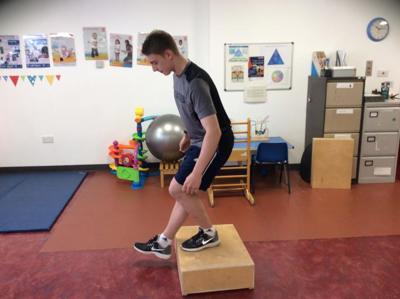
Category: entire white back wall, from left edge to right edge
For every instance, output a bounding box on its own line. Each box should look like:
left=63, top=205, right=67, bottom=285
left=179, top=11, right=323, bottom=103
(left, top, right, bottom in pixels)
left=0, top=0, right=400, bottom=167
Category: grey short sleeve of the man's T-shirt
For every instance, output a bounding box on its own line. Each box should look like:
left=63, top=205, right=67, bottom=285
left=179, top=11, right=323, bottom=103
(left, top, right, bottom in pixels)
left=190, top=79, right=216, bottom=119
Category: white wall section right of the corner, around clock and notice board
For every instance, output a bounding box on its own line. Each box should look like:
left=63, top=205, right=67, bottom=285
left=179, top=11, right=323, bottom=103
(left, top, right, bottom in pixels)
left=210, top=0, right=400, bottom=163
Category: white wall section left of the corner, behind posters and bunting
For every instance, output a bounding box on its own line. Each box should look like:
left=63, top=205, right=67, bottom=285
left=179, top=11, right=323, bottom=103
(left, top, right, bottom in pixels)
left=0, top=0, right=208, bottom=166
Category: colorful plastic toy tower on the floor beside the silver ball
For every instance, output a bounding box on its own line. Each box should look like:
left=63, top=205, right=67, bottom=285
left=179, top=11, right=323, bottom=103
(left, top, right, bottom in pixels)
left=108, top=107, right=156, bottom=190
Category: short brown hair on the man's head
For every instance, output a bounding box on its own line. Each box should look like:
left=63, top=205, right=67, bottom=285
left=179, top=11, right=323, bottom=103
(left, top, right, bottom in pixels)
left=142, top=30, right=179, bottom=56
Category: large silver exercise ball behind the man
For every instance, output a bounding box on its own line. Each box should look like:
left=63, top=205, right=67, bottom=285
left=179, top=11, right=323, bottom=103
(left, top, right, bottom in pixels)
left=146, top=114, right=184, bottom=162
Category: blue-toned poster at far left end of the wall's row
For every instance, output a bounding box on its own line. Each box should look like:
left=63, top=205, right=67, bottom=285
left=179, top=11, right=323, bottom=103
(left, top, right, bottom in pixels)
left=0, top=35, right=22, bottom=69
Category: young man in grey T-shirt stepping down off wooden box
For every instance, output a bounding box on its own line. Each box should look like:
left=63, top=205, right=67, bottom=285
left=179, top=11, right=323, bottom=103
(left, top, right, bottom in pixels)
left=133, top=30, right=234, bottom=259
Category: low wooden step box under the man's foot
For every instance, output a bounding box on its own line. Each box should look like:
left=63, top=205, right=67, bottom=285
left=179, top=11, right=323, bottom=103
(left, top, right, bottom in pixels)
left=176, top=224, right=254, bottom=295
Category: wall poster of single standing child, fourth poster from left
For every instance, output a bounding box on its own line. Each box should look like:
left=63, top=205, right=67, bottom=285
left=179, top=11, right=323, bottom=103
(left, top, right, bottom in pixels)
left=83, top=27, right=108, bottom=60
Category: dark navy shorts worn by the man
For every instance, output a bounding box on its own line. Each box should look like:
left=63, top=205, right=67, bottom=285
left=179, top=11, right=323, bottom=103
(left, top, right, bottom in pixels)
left=175, top=128, right=234, bottom=191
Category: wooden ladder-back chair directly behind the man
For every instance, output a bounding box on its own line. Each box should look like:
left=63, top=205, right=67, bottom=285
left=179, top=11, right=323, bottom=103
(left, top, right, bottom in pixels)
left=207, top=119, right=254, bottom=207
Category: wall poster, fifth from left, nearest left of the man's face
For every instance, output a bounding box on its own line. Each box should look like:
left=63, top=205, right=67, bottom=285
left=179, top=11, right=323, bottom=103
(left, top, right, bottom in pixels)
left=110, top=33, right=133, bottom=67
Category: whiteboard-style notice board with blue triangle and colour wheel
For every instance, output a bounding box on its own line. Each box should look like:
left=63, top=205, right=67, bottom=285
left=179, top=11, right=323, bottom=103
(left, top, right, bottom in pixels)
left=224, top=42, right=294, bottom=91
